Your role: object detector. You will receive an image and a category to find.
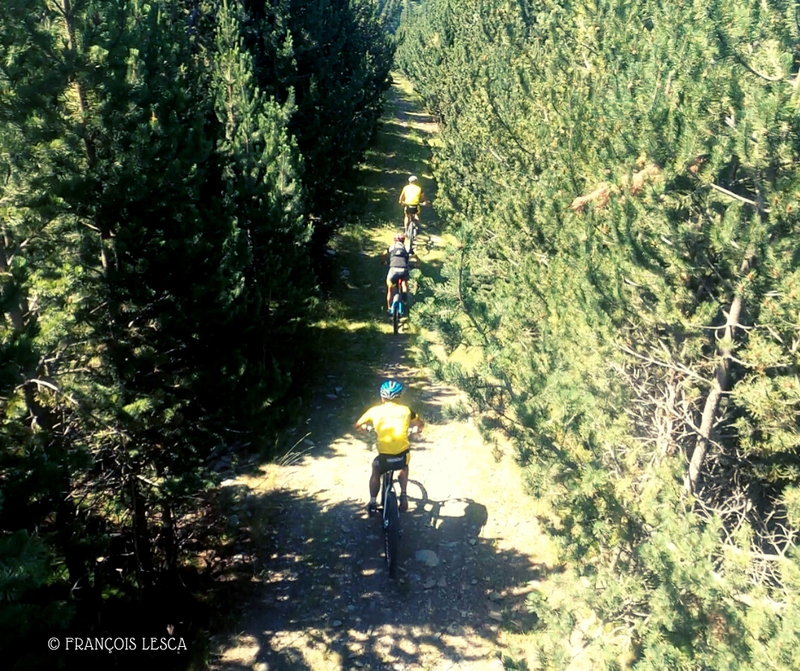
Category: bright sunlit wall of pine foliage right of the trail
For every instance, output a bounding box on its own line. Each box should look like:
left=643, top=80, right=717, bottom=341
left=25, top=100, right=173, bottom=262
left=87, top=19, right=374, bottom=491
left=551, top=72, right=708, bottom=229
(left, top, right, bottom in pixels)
left=397, top=0, right=800, bottom=670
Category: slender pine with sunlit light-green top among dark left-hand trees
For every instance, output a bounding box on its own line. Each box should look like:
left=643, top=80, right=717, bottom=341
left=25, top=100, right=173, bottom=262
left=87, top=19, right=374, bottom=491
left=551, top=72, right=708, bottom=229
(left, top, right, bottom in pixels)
left=209, top=2, right=313, bottom=420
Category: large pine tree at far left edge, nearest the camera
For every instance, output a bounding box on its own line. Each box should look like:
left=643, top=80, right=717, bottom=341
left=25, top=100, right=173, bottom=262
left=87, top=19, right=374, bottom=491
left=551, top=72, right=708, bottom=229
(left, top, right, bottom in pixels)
left=0, top=2, right=236, bottom=644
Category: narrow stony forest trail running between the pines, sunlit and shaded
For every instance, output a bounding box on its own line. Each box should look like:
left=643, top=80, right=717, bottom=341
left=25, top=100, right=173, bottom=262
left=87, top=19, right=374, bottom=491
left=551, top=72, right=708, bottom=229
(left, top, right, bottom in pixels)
left=206, top=75, right=552, bottom=671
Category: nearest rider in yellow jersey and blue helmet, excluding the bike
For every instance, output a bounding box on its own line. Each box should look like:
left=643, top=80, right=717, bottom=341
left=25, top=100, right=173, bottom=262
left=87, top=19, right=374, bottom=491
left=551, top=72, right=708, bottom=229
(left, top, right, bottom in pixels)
left=355, top=380, right=425, bottom=517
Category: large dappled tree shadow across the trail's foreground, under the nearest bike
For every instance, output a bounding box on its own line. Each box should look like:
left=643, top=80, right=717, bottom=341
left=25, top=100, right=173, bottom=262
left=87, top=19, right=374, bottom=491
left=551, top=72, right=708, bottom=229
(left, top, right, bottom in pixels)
left=211, top=480, right=544, bottom=671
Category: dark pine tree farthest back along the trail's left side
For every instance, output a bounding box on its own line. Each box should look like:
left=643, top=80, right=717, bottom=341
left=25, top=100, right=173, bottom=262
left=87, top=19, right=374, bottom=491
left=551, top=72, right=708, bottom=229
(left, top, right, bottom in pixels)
left=276, top=0, right=392, bottom=242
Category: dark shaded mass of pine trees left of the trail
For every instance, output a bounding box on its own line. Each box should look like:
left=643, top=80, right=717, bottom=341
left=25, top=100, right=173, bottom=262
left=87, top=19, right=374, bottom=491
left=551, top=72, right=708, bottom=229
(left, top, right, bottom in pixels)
left=0, top=0, right=391, bottom=669
